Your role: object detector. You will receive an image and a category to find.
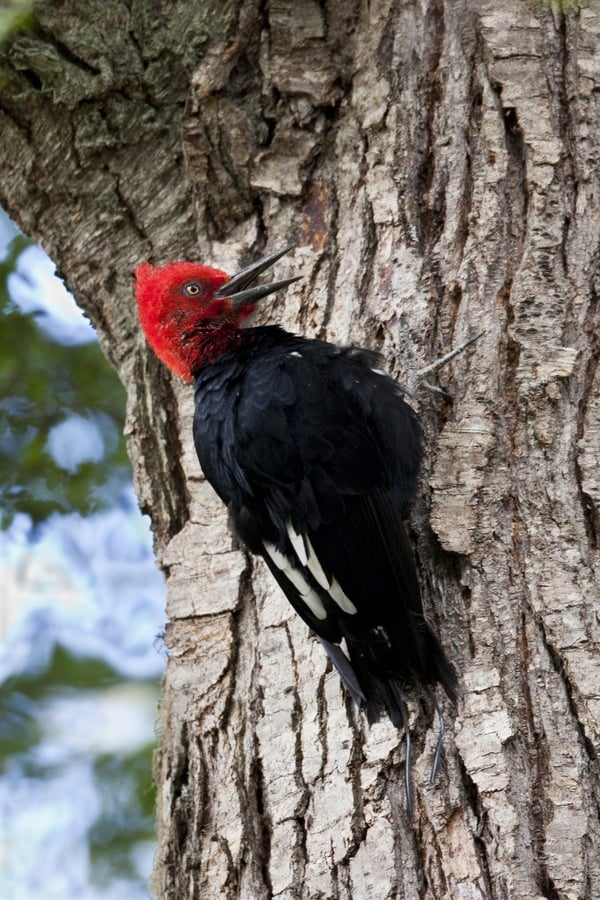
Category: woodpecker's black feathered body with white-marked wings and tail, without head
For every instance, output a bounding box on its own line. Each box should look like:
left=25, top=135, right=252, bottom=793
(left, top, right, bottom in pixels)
left=196, top=339, right=454, bottom=725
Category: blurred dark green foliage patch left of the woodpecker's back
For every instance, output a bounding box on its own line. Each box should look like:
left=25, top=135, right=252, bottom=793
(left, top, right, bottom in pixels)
left=0, top=237, right=131, bottom=528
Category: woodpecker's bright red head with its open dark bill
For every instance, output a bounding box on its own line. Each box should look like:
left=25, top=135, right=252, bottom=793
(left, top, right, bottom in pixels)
left=135, top=247, right=296, bottom=381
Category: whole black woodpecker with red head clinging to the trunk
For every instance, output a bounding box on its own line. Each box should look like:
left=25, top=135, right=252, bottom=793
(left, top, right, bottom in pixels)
left=135, top=245, right=456, bottom=807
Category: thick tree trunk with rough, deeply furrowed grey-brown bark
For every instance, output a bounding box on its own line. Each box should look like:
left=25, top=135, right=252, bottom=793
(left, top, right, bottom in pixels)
left=0, top=0, right=600, bottom=900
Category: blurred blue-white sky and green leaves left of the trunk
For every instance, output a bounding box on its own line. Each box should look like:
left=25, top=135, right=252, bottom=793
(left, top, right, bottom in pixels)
left=0, top=216, right=164, bottom=900
